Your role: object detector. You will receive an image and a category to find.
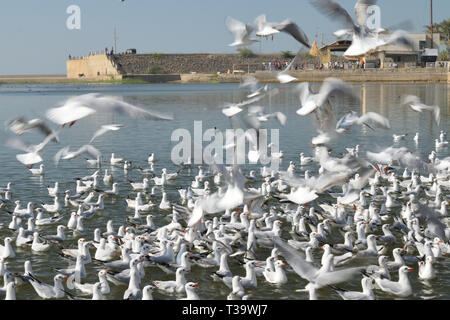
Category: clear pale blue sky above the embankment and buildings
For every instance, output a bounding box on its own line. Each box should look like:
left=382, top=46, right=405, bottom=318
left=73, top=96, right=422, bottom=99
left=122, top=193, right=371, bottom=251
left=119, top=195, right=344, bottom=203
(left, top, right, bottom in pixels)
left=0, top=0, right=450, bottom=75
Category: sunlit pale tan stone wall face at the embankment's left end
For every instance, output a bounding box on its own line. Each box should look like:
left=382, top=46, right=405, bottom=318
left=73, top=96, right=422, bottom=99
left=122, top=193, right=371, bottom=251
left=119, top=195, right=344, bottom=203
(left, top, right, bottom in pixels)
left=67, top=54, right=122, bottom=80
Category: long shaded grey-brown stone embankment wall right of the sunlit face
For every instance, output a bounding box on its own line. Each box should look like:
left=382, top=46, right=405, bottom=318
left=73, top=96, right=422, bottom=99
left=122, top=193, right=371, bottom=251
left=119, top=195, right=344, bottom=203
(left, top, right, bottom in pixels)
left=109, top=54, right=345, bottom=74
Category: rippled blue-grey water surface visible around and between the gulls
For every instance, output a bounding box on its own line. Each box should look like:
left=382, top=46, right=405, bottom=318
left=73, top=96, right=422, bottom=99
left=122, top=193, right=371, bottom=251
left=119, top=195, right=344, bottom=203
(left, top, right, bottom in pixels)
left=0, top=83, right=450, bottom=299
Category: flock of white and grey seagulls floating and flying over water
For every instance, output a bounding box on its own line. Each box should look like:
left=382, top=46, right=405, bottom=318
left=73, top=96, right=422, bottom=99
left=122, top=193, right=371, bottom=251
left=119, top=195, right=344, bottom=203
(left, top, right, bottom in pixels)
left=0, top=0, right=450, bottom=300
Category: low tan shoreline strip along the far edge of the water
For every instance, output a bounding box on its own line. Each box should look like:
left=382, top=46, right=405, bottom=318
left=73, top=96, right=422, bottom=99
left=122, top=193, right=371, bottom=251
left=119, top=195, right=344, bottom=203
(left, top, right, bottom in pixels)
left=0, top=69, right=450, bottom=85
